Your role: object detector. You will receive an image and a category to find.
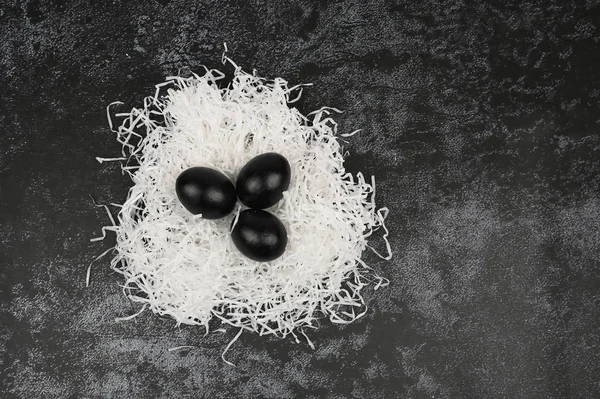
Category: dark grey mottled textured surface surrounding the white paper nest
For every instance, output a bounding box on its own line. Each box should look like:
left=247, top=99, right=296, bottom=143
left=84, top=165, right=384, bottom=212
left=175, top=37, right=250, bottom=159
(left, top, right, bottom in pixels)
left=0, top=0, right=600, bottom=398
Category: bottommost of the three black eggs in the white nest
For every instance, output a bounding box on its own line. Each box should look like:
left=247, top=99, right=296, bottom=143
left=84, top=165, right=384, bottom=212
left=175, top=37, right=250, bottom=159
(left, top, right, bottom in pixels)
left=231, top=209, right=287, bottom=262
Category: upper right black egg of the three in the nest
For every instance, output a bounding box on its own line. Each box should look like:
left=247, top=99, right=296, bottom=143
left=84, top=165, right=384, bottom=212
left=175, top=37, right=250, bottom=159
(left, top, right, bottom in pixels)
left=236, top=152, right=292, bottom=209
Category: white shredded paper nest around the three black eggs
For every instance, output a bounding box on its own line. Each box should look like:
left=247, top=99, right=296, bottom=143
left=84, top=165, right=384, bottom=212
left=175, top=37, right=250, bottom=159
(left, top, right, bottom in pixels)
left=98, top=59, right=391, bottom=343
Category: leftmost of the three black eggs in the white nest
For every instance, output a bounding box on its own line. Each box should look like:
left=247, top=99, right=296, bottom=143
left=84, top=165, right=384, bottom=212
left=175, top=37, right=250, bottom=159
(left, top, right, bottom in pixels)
left=175, top=167, right=237, bottom=219
